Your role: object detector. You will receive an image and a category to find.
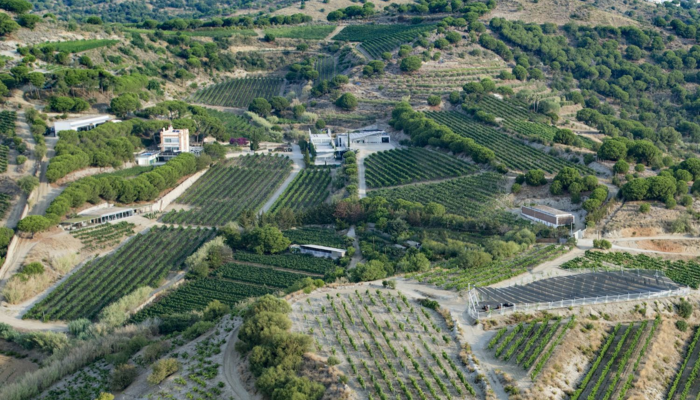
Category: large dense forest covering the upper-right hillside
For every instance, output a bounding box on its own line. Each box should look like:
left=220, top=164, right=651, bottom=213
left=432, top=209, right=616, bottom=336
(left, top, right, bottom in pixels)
left=482, top=18, right=700, bottom=153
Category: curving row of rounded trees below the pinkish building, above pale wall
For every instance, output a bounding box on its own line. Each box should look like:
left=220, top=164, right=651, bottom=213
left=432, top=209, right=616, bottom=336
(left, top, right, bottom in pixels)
left=17, top=153, right=197, bottom=234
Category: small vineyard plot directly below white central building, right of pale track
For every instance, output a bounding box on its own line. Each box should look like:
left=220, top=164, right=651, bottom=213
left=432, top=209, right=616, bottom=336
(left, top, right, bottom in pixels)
left=271, top=168, right=331, bottom=213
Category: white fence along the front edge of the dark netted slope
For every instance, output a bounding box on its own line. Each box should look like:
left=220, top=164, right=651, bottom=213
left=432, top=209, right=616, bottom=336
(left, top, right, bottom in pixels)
left=468, top=288, right=690, bottom=319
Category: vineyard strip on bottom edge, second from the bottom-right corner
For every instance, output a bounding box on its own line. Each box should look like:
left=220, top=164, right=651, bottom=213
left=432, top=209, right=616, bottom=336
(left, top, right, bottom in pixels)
left=571, top=318, right=661, bottom=400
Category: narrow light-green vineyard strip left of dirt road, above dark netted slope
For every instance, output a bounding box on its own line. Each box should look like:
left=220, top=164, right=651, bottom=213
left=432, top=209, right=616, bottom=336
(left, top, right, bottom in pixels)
left=406, top=245, right=568, bottom=290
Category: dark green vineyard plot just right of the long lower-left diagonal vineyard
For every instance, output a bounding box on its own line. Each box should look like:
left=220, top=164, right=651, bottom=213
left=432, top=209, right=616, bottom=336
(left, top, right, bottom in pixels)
left=133, top=277, right=274, bottom=322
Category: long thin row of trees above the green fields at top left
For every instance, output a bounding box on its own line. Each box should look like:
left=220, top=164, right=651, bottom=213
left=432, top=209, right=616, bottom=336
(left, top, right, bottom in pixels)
left=145, top=13, right=313, bottom=31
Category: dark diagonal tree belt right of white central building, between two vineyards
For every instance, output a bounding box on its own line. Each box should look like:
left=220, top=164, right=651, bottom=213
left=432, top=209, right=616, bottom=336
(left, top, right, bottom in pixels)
left=389, top=102, right=496, bottom=164
